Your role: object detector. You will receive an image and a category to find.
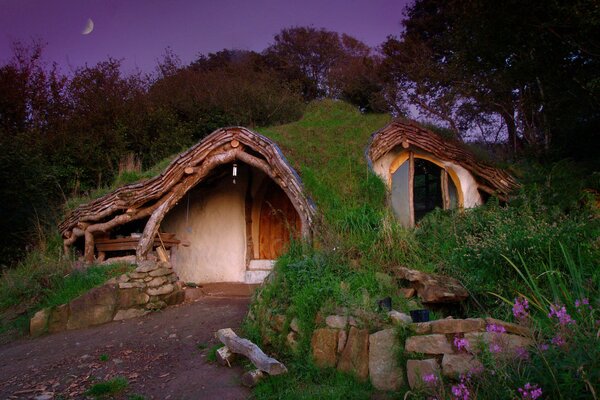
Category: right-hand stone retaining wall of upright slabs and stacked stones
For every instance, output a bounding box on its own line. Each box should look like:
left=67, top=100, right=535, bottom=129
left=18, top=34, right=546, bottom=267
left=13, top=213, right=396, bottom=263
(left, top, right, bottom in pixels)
left=308, top=311, right=532, bottom=391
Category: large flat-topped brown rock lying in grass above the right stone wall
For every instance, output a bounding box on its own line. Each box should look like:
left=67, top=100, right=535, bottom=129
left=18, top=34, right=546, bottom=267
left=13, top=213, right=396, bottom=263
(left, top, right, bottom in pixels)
left=398, top=267, right=469, bottom=303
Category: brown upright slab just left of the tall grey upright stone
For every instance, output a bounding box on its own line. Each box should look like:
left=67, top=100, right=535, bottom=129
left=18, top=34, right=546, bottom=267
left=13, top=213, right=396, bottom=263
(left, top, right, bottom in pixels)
left=337, top=327, right=369, bottom=380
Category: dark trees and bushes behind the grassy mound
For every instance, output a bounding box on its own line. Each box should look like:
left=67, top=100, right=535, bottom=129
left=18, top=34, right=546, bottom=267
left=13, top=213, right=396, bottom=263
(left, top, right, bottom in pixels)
left=0, top=0, right=600, bottom=265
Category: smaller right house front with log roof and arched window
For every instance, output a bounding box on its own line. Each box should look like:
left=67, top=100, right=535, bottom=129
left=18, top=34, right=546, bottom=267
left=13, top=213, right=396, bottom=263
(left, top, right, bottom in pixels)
left=366, top=119, right=518, bottom=227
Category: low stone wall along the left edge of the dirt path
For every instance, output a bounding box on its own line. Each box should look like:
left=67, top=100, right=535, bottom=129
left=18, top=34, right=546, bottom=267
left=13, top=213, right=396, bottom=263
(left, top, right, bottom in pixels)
left=29, top=261, right=185, bottom=336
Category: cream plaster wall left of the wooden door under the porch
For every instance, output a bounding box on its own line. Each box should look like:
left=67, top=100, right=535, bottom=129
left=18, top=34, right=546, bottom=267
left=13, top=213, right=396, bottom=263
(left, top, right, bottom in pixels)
left=161, top=176, right=247, bottom=283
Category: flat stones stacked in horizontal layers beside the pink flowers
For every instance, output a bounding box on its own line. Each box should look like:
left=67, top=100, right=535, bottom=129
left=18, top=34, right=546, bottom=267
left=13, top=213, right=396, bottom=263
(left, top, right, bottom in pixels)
left=404, top=318, right=533, bottom=388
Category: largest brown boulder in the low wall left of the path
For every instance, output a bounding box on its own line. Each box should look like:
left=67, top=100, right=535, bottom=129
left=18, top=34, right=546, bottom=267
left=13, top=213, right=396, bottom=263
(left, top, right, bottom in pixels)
left=67, top=285, right=117, bottom=329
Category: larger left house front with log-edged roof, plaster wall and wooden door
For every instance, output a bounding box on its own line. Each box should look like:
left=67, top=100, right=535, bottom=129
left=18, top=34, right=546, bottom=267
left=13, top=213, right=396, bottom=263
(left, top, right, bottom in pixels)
left=59, top=127, right=315, bottom=283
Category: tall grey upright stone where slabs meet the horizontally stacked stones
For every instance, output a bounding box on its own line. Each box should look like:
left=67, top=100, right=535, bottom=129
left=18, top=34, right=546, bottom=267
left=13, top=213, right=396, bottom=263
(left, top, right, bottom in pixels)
left=369, top=329, right=403, bottom=391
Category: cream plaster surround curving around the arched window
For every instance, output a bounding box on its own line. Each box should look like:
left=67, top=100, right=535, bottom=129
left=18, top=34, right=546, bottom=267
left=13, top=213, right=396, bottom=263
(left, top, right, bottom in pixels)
left=373, top=148, right=483, bottom=208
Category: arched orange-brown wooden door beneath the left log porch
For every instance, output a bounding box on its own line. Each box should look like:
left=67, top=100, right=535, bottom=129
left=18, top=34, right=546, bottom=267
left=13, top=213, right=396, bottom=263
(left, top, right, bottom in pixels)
left=259, top=181, right=301, bottom=260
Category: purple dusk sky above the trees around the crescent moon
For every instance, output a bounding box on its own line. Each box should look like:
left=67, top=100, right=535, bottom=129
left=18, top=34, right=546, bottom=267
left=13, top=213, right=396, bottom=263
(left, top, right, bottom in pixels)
left=0, top=0, right=408, bottom=72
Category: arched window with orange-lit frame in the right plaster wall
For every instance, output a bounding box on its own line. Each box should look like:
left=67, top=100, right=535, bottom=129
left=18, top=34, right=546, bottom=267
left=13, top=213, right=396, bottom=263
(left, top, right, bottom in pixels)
left=390, top=152, right=462, bottom=227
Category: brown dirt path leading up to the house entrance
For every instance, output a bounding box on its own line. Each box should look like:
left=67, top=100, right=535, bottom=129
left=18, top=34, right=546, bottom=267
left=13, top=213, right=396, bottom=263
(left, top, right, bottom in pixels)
left=0, top=290, right=250, bottom=400
